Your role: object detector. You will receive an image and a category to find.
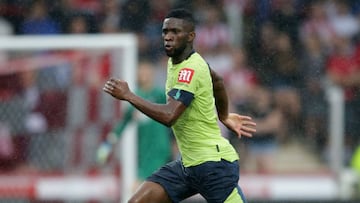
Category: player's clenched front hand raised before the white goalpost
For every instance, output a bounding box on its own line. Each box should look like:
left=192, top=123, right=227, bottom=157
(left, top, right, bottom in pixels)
left=103, top=78, right=131, bottom=100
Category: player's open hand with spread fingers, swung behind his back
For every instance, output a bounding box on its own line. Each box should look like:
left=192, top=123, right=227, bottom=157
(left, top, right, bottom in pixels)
left=221, top=113, right=256, bottom=138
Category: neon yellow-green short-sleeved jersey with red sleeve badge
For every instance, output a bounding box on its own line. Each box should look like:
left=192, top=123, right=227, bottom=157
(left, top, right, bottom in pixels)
left=166, top=52, right=239, bottom=167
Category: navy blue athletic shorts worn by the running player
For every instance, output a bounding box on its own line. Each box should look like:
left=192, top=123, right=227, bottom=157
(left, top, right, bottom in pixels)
left=147, top=160, right=246, bottom=203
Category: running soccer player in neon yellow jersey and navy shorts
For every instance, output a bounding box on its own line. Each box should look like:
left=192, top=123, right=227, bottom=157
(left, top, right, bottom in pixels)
left=103, top=9, right=256, bottom=203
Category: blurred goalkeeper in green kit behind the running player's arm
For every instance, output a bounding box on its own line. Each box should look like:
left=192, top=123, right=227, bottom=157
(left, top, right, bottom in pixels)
left=96, top=61, right=172, bottom=182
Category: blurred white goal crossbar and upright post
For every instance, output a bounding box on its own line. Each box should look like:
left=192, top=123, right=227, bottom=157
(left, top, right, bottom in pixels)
left=0, top=33, right=138, bottom=202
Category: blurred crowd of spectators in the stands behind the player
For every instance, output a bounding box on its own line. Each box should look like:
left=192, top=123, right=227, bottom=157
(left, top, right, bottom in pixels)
left=0, top=0, right=360, bottom=173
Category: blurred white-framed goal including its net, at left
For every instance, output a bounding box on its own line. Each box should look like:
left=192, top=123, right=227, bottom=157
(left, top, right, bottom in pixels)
left=0, top=34, right=137, bottom=202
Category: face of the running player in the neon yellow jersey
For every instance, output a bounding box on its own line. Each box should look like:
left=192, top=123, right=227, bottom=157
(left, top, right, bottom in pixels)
left=162, top=18, right=189, bottom=57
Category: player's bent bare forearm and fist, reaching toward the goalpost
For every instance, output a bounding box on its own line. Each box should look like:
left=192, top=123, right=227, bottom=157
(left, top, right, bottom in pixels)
left=103, top=79, right=186, bottom=127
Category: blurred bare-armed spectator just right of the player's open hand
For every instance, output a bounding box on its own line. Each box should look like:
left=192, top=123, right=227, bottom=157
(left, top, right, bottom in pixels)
left=243, top=86, right=287, bottom=174
